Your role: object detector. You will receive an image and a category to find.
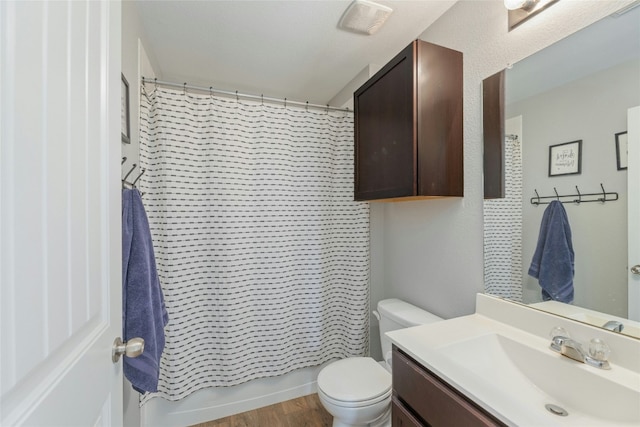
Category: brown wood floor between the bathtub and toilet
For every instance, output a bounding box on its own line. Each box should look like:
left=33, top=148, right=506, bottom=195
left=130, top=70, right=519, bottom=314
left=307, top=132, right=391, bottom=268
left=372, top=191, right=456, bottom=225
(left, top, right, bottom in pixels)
left=192, top=394, right=333, bottom=427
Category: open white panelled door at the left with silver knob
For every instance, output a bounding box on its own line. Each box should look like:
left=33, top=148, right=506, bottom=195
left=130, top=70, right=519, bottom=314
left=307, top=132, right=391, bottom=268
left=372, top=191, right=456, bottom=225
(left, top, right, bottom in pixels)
left=0, top=0, right=122, bottom=426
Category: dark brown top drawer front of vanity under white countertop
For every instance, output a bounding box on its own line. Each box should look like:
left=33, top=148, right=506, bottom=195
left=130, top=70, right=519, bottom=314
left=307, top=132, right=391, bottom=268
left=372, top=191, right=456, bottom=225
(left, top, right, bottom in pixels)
left=392, top=346, right=504, bottom=427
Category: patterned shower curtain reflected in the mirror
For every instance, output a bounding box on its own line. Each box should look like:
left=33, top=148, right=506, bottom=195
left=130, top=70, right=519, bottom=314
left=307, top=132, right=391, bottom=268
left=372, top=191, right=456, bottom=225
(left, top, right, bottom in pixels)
left=484, top=135, right=522, bottom=301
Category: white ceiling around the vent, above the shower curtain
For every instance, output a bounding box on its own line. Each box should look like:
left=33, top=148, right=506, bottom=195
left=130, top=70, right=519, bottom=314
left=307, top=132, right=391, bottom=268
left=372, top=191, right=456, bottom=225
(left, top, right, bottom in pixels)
left=135, top=0, right=456, bottom=105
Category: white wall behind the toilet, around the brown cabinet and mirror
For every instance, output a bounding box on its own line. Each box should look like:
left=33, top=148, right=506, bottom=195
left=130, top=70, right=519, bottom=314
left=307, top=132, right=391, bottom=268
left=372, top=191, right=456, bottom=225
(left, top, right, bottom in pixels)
left=372, top=0, right=631, bottom=318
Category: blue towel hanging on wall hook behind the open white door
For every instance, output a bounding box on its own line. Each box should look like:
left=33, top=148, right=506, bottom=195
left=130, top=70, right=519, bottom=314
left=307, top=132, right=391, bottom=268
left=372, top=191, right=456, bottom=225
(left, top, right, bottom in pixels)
left=122, top=189, right=169, bottom=393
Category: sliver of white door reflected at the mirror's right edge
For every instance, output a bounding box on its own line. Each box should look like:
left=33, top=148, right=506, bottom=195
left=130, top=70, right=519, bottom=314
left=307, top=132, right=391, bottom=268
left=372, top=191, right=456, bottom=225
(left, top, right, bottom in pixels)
left=627, top=106, right=640, bottom=321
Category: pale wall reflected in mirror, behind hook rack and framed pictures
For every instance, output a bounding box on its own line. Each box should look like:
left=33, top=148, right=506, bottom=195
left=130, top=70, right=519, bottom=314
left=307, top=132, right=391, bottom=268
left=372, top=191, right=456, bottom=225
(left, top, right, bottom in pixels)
left=507, top=60, right=640, bottom=317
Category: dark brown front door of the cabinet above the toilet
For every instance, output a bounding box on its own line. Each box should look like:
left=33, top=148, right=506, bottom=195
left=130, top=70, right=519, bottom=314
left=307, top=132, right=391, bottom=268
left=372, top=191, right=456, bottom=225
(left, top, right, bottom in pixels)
left=354, top=43, right=417, bottom=200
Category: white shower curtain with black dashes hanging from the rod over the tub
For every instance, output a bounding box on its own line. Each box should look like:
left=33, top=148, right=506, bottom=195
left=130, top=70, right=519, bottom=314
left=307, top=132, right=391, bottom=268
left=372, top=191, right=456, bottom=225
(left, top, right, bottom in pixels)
left=139, top=87, right=369, bottom=404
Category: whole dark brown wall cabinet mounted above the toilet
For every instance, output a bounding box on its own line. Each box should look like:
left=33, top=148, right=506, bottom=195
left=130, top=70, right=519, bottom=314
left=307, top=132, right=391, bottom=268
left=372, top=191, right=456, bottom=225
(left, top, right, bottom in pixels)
left=354, top=40, right=464, bottom=200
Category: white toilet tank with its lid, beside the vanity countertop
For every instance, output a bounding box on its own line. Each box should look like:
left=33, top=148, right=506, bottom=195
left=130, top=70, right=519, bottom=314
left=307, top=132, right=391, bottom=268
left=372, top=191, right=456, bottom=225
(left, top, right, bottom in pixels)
left=378, top=298, right=443, bottom=366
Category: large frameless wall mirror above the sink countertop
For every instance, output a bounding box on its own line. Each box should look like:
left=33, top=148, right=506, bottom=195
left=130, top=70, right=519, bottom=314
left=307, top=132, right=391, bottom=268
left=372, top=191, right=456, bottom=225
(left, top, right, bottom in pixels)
left=485, top=3, right=640, bottom=338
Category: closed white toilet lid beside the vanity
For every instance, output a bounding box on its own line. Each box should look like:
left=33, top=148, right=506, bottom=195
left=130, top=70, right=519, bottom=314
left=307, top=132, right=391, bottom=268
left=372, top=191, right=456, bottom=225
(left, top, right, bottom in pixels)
left=318, top=357, right=391, bottom=402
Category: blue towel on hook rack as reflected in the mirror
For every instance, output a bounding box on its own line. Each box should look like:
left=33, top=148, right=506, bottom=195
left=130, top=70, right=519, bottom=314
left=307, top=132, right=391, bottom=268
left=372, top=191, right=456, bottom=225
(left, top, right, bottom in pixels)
left=529, top=200, right=574, bottom=303
